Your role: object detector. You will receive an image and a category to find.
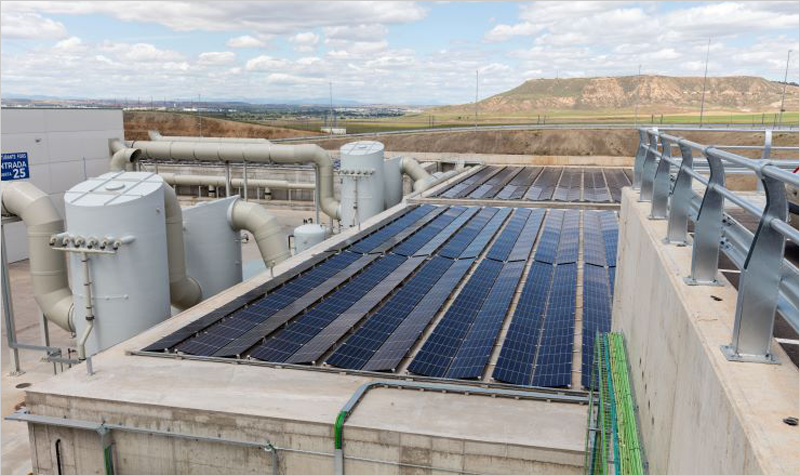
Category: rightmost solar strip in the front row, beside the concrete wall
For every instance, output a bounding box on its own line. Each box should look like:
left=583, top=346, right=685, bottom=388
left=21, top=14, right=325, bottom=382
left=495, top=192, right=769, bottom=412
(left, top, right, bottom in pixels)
left=581, top=264, right=611, bottom=388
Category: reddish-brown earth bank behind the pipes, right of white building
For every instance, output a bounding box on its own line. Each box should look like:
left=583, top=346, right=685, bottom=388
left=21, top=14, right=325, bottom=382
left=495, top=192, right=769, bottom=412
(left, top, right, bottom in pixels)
left=123, top=111, right=308, bottom=140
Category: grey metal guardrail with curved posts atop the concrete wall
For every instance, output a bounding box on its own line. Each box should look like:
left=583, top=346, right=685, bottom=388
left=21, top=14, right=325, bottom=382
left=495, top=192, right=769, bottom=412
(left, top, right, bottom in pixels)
left=633, top=128, right=800, bottom=363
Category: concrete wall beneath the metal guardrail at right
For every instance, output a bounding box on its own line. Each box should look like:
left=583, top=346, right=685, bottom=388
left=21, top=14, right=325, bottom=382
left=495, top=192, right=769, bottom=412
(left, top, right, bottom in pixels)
left=613, top=188, right=800, bottom=474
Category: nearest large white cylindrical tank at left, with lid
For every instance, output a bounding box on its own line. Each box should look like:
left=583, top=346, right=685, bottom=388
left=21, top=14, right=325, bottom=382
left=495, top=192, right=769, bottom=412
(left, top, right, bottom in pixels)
left=64, top=172, right=170, bottom=356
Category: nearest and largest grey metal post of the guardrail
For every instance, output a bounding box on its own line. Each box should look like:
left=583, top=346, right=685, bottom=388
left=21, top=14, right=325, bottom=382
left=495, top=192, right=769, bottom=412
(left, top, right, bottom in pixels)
left=722, top=161, right=788, bottom=363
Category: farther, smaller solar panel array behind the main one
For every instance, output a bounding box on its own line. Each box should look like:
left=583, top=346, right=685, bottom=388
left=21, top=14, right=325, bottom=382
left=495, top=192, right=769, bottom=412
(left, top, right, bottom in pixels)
left=434, top=165, right=631, bottom=203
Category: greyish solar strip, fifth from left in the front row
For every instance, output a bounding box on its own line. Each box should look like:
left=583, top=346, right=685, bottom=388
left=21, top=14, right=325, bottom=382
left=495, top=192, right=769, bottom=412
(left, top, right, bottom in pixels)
left=286, top=257, right=425, bottom=364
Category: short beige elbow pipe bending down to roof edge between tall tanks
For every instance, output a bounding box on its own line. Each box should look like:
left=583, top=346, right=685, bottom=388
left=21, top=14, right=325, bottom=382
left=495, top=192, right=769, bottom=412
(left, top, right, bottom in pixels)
left=228, top=200, right=290, bottom=268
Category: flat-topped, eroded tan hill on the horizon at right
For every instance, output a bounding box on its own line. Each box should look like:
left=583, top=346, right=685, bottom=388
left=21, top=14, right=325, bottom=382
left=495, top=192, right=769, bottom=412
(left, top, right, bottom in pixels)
left=438, top=76, right=798, bottom=115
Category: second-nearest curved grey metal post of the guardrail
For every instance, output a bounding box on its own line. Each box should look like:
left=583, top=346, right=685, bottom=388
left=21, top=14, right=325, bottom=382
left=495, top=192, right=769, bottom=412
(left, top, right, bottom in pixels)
left=685, top=147, right=725, bottom=285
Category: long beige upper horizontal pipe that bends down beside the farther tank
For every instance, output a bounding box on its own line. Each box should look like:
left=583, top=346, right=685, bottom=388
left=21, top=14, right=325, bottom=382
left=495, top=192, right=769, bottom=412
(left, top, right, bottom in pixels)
left=124, top=141, right=341, bottom=220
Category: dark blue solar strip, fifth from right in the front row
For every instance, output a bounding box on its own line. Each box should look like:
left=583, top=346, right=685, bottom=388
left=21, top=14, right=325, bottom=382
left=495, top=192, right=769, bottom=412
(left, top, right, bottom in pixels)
left=408, top=260, right=503, bottom=377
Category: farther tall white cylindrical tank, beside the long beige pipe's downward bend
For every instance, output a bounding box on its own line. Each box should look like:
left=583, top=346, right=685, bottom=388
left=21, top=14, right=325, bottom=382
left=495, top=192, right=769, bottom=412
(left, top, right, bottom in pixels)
left=339, top=141, right=384, bottom=227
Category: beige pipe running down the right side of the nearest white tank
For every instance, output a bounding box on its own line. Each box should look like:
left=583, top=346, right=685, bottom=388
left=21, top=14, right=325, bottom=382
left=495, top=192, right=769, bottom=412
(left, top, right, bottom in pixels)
left=164, top=185, right=203, bottom=310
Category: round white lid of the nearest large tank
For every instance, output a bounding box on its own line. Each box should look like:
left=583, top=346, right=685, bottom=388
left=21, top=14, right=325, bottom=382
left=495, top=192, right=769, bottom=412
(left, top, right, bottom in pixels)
left=64, top=172, right=164, bottom=207
